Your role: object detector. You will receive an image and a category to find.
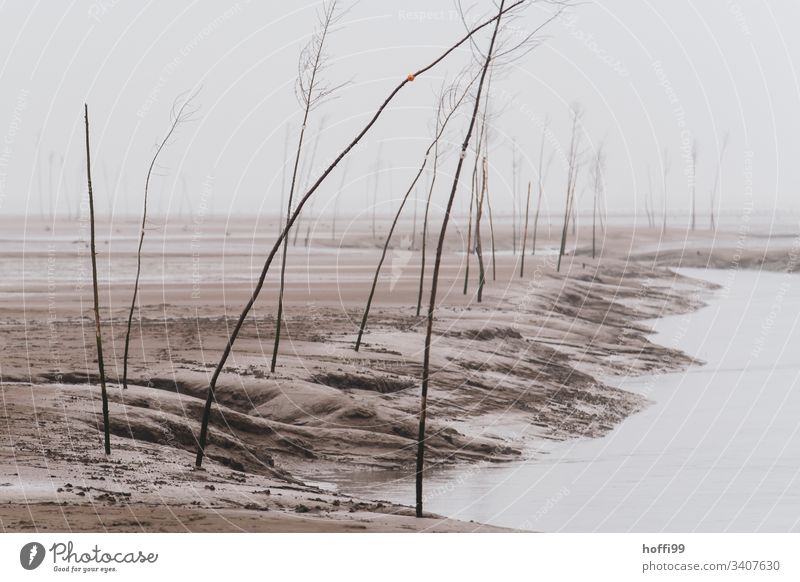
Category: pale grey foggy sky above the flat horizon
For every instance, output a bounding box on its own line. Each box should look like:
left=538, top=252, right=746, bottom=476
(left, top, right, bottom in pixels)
left=0, top=0, right=800, bottom=225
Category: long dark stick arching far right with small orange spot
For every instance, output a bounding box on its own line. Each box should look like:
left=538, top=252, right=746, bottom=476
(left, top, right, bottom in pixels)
left=195, top=0, right=526, bottom=467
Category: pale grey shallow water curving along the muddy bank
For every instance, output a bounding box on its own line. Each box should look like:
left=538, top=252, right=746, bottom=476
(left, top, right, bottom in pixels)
left=323, top=269, right=800, bottom=532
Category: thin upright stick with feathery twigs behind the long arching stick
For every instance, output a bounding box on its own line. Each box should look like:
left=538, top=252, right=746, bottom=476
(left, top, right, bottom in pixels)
left=274, top=0, right=340, bottom=374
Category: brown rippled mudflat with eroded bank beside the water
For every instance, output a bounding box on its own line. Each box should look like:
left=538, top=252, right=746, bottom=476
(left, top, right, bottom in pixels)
left=0, top=219, right=792, bottom=531
